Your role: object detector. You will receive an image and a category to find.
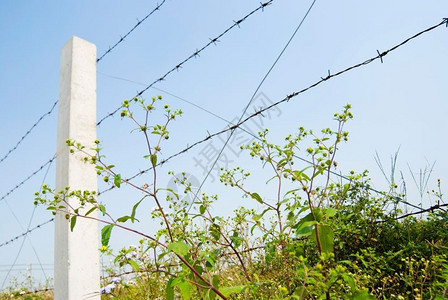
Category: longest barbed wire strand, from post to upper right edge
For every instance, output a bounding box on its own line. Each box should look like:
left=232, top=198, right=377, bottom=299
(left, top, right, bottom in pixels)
left=98, top=18, right=448, bottom=197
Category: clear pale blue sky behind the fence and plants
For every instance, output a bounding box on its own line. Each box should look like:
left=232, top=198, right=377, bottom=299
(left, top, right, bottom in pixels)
left=0, top=0, right=448, bottom=290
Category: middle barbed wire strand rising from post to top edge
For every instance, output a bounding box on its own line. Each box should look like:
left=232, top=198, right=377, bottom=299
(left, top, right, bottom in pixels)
left=96, top=0, right=274, bottom=126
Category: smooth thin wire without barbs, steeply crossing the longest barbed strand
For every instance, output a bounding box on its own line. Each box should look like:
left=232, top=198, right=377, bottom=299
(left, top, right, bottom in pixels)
left=187, top=0, right=316, bottom=213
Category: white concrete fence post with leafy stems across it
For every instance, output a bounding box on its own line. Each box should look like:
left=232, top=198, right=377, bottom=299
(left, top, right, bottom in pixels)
left=54, top=37, right=100, bottom=300
